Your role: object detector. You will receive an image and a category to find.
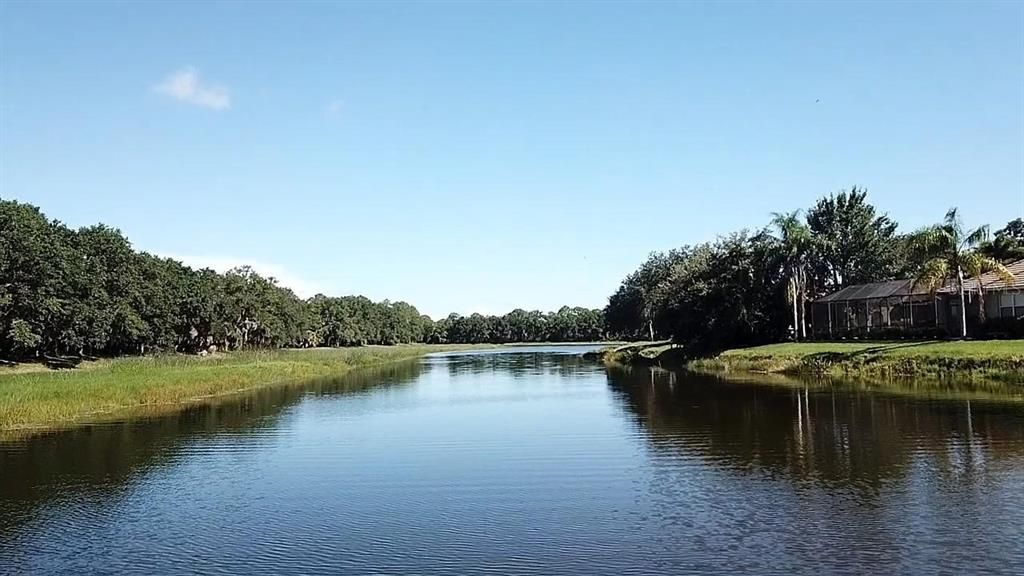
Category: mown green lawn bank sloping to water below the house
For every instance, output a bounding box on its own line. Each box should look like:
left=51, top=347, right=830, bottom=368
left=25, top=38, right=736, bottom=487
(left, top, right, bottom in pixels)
left=688, top=340, right=1024, bottom=384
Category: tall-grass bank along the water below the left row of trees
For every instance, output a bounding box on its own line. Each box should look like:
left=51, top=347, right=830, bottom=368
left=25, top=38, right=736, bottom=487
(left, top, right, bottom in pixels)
left=0, top=345, right=494, bottom=435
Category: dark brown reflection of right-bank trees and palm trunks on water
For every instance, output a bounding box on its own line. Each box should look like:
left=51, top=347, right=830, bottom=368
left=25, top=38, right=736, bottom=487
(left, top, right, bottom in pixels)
left=608, top=360, right=1024, bottom=489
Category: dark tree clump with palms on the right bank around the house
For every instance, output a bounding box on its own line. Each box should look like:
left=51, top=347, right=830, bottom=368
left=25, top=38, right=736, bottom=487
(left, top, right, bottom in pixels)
left=604, top=188, right=1024, bottom=355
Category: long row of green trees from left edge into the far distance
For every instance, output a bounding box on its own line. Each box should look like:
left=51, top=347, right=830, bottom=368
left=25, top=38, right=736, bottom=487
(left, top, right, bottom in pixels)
left=0, top=199, right=604, bottom=359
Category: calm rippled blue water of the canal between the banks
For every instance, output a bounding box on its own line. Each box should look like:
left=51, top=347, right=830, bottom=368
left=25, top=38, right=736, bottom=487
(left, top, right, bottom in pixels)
left=0, top=342, right=1024, bottom=575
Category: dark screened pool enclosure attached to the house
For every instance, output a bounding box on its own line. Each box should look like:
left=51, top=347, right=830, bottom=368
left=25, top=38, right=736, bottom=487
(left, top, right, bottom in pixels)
left=811, top=280, right=948, bottom=338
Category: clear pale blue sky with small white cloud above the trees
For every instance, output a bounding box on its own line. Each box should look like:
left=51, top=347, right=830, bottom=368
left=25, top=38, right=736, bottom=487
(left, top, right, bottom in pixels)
left=0, top=1, right=1024, bottom=317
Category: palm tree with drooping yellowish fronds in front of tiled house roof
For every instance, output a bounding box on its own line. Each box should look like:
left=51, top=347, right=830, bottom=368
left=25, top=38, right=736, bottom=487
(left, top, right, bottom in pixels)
left=910, top=208, right=1014, bottom=338
